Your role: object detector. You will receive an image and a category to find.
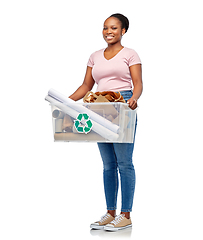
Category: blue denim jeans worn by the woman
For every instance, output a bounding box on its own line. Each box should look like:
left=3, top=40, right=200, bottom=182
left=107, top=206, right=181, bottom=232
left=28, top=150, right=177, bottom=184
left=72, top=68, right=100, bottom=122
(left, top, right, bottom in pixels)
left=98, top=91, right=137, bottom=212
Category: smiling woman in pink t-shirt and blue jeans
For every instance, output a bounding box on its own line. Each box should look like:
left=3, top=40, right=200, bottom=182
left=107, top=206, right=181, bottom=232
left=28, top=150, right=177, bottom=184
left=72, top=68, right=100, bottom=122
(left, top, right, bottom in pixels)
left=70, top=14, right=142, bottom=231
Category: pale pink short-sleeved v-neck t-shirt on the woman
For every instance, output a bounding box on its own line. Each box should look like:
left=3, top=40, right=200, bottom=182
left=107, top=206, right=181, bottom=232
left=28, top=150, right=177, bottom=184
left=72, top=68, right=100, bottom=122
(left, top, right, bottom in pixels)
left=87, top=47, right=141, bottom=92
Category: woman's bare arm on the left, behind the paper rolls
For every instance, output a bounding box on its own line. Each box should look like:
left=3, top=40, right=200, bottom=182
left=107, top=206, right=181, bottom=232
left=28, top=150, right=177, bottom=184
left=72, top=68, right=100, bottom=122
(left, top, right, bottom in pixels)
left=69, top=66, right=95, bottom=101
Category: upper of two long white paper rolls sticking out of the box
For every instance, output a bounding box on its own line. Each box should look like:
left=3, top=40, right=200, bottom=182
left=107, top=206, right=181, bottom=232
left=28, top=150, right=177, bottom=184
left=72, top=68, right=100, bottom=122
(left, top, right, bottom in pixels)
left=48, top=89, right=119, bottom=133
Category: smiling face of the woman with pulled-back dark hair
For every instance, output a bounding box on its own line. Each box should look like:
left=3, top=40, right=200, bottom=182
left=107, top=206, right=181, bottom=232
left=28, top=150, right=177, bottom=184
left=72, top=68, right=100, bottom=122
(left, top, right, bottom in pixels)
left=103, top=17, right=125, bottom=44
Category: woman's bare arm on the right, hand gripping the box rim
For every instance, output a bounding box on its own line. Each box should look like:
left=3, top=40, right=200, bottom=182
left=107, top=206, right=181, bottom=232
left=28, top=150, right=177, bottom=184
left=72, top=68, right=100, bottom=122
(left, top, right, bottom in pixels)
left=128, top=64, right=143, bottom=110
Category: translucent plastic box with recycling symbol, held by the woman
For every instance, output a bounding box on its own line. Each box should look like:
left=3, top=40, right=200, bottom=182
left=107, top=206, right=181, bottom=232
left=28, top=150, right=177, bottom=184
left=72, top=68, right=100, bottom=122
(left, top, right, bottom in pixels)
left=51, top=103, right=136, bottom=143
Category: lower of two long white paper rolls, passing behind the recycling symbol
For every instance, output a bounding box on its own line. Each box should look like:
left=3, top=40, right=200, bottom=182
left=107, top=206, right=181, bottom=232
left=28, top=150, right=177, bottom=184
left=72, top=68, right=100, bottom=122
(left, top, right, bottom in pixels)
left=45, top=96, right=119, bottom=141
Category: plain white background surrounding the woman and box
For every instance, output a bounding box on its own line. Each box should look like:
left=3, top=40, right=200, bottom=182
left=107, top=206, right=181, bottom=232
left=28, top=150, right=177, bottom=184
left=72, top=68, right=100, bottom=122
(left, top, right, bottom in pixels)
left=0, top=0, right=203, bottom=240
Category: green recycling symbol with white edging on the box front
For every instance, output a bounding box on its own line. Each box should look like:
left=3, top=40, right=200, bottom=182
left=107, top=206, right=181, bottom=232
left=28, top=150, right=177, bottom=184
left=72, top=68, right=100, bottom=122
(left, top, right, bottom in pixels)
left=74, top=113, right=92, bottom=134
